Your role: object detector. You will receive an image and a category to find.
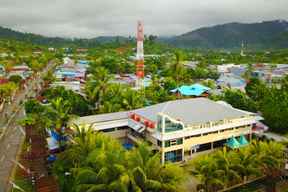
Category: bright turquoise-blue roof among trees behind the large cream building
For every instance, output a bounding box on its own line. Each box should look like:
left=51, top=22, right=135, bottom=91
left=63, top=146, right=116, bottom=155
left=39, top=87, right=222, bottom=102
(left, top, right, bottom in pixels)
left=170, top=84, right=210, bottom=96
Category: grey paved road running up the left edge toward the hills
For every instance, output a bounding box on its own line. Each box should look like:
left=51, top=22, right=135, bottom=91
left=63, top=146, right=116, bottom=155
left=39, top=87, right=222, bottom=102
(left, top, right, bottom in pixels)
left=0, top=62, right=54, bottom=192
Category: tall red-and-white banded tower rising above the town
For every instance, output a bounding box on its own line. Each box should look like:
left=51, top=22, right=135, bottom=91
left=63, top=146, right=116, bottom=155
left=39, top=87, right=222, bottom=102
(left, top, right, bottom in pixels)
left=136, top=21, right=144, bottom=87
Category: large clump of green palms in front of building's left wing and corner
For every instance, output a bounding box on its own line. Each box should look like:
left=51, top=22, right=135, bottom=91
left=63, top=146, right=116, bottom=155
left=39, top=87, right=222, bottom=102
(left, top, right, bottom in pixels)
left=53, top=126, right=185, bottom=192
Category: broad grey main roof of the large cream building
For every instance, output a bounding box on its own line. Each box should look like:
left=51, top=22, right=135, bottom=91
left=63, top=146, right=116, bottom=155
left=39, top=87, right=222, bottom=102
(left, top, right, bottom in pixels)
left=133, top=98, right=248, bottom=124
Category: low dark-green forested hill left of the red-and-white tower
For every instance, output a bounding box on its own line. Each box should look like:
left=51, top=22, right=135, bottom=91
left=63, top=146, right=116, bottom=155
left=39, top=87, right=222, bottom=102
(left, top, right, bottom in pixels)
left=0, top=26, right=127, bottom=47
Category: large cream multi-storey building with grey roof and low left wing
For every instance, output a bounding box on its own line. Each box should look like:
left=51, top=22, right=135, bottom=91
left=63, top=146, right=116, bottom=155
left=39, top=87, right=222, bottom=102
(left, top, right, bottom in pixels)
left=75, top=98, right=257, bottom=163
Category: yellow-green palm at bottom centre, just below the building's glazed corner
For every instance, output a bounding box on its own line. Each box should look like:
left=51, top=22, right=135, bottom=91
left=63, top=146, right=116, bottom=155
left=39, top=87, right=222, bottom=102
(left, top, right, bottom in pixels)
left=128, top=143, right=185, bottom=191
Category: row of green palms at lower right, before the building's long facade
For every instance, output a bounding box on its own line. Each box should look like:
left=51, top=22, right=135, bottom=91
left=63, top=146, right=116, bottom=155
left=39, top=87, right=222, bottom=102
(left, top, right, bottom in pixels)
left=187, top=141, right=284, bottom=192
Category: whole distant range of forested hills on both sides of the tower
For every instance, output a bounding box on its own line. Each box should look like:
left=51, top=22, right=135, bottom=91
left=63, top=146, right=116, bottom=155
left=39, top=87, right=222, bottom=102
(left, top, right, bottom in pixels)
left=0, top=20, right=288, bottom=50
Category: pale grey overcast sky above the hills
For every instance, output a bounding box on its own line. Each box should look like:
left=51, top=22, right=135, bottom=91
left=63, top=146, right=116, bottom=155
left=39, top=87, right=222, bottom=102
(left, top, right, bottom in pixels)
left=0, top=0, right=288, bottom=37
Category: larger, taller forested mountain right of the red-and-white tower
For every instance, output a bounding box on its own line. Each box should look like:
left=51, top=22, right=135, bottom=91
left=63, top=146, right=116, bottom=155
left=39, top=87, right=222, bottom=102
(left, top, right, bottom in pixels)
left=165, top=20, right=288, bottom=49
